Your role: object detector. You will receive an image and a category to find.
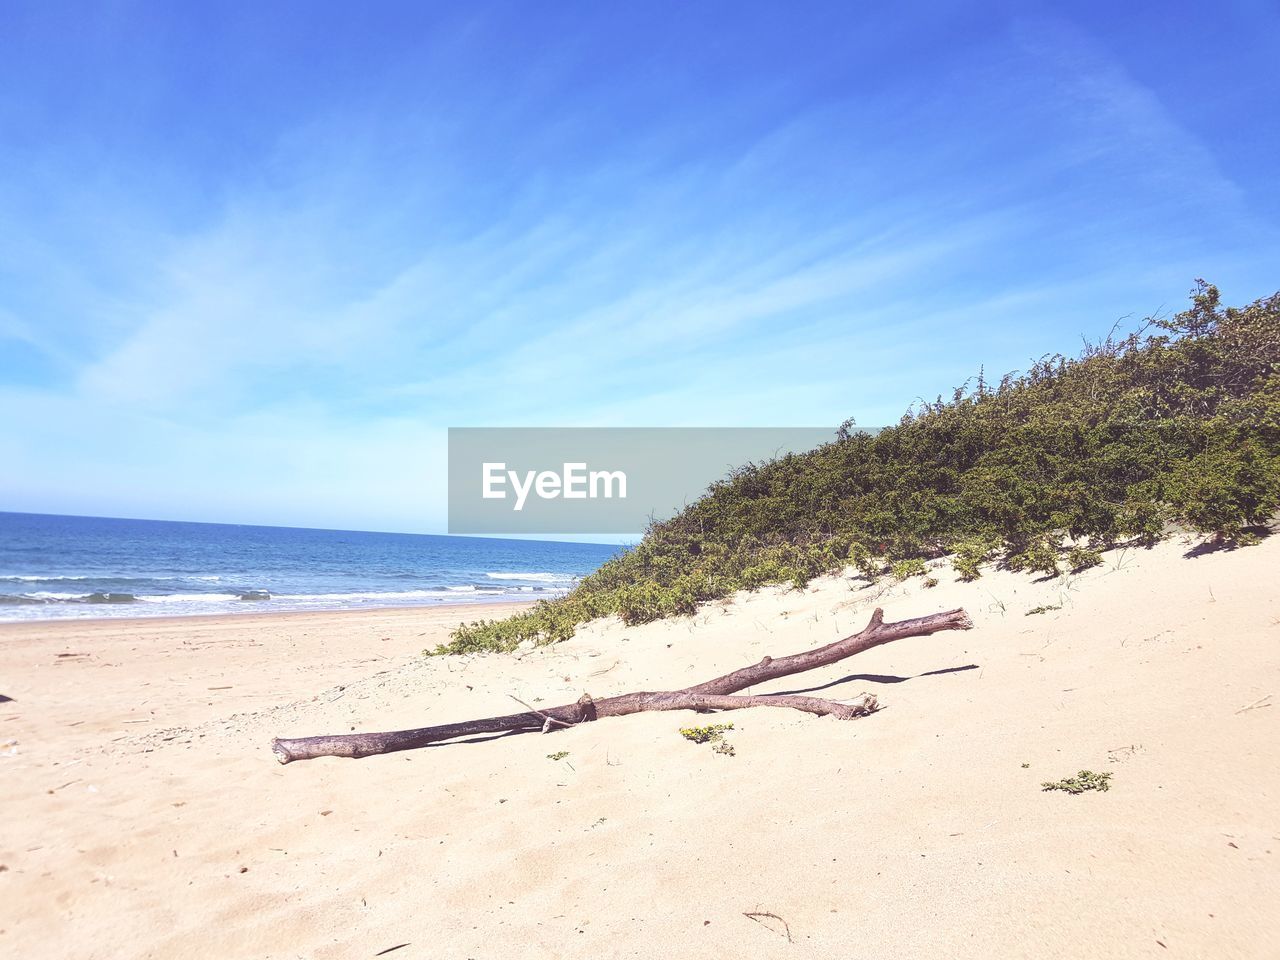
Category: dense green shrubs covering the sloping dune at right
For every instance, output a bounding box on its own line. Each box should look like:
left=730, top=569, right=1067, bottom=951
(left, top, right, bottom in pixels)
left=430, top=280, right=1280, bottom=653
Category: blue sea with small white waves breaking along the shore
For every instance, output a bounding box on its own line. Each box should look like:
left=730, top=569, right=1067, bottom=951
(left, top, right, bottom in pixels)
left=0, top=512, right=621, bottom=621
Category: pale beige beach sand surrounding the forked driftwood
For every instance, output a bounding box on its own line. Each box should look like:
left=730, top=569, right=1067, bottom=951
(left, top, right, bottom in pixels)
left=0, top=536, right=1280, bottom=960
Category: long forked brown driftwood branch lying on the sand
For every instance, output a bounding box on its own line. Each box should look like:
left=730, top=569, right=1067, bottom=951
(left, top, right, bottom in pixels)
left=271, top=608, right=973, bottom=763
